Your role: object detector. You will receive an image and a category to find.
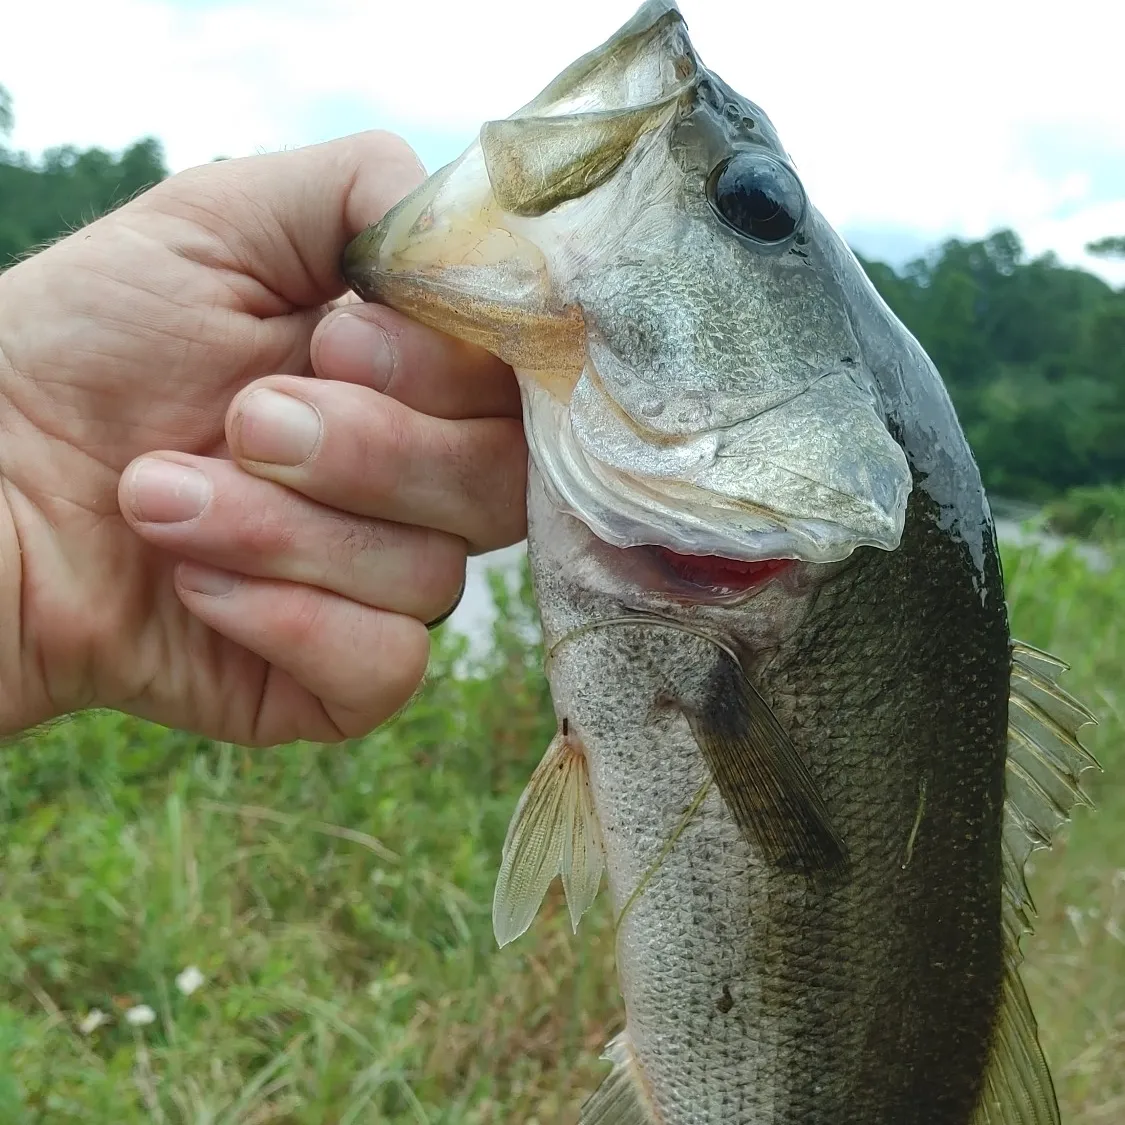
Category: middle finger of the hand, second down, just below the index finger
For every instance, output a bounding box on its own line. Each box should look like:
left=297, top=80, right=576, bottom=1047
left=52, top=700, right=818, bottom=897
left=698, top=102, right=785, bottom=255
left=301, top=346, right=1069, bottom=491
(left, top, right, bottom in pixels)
left=226, top=376, right=528, bottom=551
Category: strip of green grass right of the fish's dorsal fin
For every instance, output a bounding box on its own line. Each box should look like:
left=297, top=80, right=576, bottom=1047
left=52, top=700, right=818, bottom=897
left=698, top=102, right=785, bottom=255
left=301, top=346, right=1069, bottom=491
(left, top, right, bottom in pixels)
left=1006, top=545, right=1125, bottom=1125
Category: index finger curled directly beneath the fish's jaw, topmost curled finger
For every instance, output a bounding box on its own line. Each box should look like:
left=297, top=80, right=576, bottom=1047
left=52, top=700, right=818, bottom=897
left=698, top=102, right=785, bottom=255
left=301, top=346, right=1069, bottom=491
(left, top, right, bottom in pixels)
left=312, top=304, right=521, bottom=419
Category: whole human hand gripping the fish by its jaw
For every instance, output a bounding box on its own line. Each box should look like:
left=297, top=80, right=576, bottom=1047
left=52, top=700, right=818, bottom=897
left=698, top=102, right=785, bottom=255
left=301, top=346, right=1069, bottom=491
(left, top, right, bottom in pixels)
left=0, top=134, right=527, bottom=745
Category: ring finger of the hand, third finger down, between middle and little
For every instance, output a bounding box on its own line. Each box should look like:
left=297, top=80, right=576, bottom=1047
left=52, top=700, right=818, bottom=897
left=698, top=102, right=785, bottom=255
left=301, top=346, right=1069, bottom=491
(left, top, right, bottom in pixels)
left=119, top=452, right=466, bottom=621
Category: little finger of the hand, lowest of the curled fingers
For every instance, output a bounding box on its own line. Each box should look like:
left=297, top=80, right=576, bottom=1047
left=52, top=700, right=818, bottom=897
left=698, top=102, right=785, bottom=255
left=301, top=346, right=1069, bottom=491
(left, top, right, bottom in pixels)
left=176, top=563, right=430, bottom=745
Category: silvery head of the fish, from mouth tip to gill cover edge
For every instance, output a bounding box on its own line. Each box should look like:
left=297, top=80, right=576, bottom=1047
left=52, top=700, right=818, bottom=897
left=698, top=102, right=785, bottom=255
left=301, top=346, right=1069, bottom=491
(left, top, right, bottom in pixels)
left=343, top=0, right=911, bottom=563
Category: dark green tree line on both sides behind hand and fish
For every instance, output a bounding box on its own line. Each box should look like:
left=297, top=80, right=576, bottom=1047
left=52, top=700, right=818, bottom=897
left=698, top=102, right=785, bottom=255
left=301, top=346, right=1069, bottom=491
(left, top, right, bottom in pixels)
left=0, top=88, right=1125, bottom=503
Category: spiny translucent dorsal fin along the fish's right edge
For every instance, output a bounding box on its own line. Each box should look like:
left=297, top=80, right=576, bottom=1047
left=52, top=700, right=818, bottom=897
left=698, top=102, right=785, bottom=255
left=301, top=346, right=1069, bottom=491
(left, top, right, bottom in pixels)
left=972, top=641, right=1097, bottom=1125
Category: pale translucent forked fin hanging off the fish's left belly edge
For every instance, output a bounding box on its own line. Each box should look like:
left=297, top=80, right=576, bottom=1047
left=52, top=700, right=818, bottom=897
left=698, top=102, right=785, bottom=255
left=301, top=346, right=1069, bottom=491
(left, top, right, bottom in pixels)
left=493, top=734, right=605, bottom=946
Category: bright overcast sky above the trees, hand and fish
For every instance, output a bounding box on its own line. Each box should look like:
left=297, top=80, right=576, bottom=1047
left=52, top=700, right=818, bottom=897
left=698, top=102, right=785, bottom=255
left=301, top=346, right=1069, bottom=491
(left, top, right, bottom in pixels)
left=0, top=0, right=1125, bottom=284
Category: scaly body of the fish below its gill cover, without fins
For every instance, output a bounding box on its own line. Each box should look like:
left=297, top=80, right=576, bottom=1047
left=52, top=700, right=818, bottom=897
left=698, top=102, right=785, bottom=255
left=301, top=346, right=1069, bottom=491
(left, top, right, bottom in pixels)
left=530, top=472, right=1008, bottom=1125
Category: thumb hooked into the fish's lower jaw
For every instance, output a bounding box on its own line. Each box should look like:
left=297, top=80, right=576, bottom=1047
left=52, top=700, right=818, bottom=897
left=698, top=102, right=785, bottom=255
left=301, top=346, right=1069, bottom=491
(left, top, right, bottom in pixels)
left=138, top=132, right=425, bottom=307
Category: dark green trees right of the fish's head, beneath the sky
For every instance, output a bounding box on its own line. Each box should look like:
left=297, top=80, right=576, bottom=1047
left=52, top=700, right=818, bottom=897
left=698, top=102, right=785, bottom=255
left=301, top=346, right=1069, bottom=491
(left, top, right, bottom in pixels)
left=864, top=231, right=1125, bottom=501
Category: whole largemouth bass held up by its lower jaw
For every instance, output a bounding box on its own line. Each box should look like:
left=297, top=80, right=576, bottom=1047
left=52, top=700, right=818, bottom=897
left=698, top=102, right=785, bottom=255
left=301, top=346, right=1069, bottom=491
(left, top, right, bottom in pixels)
left=344, top=0, right=1092, bottom=1125
